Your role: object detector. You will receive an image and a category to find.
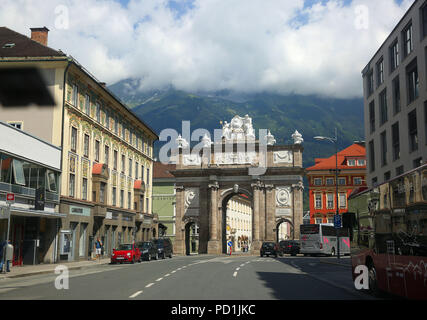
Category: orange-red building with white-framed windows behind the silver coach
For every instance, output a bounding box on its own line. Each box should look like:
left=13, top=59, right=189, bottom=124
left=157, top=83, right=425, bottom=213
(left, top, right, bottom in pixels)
left=306, top=142, right=366, bottom=224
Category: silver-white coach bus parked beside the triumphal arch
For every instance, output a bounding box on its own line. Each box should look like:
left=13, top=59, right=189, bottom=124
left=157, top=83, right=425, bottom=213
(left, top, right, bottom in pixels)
left=300, top=224, right=350, bottom=256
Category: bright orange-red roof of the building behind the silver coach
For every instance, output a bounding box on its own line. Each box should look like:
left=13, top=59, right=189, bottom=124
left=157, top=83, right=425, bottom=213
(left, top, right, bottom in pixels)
left=306, top=143, right=366, bottom=171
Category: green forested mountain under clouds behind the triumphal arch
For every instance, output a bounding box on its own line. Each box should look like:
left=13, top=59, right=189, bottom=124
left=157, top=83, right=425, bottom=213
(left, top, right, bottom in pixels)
left=110, top=86, right=364, bottom=208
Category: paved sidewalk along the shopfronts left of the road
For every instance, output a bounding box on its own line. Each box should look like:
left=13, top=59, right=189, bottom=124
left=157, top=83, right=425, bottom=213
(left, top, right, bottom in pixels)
left=0, top=258, right=110, bottom=280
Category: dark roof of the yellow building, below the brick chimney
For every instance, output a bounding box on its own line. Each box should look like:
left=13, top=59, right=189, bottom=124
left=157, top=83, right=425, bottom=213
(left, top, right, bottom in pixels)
left=0, top=27, right=66, bottom=58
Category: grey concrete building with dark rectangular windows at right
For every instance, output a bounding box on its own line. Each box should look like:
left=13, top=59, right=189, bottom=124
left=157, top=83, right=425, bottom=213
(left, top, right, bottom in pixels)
left=362, top=0, right=427, bottom=186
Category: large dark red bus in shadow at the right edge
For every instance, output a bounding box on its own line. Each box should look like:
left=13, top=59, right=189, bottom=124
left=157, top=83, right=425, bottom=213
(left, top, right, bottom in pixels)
left=343, top=164, right=427, bottom=299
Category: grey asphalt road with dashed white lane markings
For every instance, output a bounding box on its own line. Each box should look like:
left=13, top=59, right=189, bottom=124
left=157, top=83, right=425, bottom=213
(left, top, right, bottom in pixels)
left=0, top=255, right=373, bottom=301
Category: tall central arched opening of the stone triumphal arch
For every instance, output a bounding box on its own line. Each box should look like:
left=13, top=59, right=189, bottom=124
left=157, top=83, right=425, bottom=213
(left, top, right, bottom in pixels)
left=222, top=190, right=253, bottom=254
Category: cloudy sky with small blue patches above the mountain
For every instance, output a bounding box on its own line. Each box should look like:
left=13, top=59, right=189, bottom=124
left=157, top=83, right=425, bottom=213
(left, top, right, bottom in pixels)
left=0, top=0, right=414, bottom=98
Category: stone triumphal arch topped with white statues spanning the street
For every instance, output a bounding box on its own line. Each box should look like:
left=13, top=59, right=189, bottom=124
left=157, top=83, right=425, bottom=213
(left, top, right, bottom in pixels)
left=171, top=115, right=304, bottom=254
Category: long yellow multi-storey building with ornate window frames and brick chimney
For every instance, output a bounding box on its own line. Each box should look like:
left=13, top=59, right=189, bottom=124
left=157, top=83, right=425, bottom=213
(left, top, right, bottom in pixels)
left=0, top=27, right=158, bottom=260
